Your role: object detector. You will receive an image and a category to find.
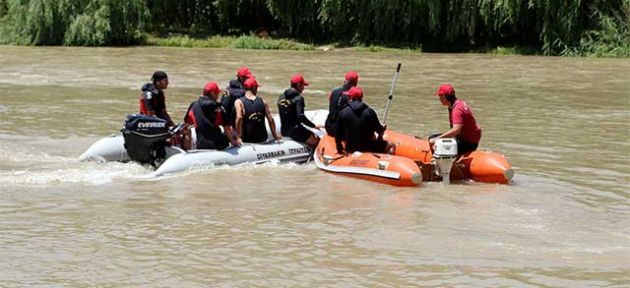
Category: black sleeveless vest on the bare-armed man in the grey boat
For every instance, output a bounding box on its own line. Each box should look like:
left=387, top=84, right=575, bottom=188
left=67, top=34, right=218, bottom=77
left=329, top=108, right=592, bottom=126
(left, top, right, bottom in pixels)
left=239, top=96, right=267, bottom=143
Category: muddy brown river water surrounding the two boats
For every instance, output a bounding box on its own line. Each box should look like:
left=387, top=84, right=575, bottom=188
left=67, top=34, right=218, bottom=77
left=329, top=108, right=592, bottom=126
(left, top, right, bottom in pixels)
left=0, top=46, right=630, bottom=287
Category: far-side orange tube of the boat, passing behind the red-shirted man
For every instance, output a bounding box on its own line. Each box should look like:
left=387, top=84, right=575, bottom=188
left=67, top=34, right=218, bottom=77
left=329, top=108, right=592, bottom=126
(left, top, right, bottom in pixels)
left=383, top=130, right=514, bottom=184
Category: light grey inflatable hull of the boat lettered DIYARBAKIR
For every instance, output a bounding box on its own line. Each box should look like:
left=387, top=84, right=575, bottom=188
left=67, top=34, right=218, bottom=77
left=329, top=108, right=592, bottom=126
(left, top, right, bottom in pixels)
left=79, top=110, right=328, bottom=176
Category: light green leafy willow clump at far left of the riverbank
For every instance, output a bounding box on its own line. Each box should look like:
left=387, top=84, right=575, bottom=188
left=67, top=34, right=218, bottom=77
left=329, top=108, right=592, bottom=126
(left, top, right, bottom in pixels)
left=0, top=0, right=149, bottom=46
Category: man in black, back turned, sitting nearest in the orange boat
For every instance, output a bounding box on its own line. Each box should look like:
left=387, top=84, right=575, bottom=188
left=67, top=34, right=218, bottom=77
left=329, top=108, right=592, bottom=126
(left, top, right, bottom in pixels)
left=335, top=87, right=393, bottom=154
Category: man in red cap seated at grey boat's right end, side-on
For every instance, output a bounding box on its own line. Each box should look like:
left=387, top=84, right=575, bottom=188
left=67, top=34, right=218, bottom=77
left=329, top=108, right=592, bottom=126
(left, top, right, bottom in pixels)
left=278, top=74, right=322, bottom=148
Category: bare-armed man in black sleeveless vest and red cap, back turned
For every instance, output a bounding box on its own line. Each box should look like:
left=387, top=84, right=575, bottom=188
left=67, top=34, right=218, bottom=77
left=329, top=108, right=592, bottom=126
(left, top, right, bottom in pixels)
left=234, top=78, right=282, bottom=145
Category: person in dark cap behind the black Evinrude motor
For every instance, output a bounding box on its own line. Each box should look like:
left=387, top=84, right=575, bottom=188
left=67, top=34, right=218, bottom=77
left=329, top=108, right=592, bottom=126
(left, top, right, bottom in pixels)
left=140, top=71, right=175, bottom=126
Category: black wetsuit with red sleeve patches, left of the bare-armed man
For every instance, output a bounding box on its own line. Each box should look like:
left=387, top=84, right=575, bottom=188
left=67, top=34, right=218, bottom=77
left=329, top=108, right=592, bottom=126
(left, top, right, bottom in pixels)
left=184, top=96, right=229, bottom=149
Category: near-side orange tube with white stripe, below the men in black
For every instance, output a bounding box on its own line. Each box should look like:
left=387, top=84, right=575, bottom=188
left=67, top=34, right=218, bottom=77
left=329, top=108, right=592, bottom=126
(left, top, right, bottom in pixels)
left=313, top=135, right=422, bottom=186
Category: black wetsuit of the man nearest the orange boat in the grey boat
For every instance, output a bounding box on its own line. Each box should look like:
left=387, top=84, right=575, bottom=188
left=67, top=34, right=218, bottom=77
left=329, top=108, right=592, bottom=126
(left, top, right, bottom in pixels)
left=278, top=89, right=315, bottom=142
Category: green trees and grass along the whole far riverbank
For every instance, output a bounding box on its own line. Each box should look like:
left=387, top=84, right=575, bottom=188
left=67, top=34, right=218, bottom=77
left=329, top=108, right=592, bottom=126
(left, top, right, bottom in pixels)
left=0, top=0, right=630, bottom=57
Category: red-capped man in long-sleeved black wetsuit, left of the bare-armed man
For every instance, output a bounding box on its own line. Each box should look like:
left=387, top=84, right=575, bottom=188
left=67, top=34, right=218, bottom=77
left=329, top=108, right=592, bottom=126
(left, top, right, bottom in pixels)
left=184, top=82, right=241, bottom=150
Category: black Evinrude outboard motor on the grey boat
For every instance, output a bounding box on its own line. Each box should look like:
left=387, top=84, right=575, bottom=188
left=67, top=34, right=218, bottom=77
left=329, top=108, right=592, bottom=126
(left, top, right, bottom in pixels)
left=121, top=114, right=172, bottom=167
